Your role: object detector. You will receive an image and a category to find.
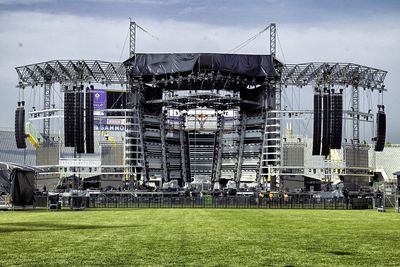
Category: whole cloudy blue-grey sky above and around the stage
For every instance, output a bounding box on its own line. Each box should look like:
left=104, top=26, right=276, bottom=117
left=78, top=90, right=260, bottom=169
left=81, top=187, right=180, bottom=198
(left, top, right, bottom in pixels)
left=0, top=0, right=400, bottom=143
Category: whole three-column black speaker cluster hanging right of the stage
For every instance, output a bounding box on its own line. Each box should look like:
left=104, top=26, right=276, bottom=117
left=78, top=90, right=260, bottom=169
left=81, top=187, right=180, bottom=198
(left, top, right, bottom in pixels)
left=312, top=90, right=343, bottom=156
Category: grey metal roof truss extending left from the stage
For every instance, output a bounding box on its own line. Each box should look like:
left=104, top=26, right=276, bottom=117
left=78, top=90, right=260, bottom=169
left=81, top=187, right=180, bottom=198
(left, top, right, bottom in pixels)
left=15, top=60, right=127, bottom=87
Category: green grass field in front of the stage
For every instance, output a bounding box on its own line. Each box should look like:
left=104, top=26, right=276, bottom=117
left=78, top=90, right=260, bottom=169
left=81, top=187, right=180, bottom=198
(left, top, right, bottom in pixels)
left=0, top=209, right=400, bottom=266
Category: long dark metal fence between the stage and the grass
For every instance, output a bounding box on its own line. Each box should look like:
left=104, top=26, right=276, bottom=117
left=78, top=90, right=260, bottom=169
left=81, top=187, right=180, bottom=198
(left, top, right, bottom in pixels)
left=32, top=194, right=373, bottom=210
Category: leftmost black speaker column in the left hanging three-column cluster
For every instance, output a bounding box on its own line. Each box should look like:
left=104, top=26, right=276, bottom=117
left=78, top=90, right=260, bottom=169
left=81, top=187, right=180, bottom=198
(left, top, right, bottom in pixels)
left=64, top=90, right=75, bottom=147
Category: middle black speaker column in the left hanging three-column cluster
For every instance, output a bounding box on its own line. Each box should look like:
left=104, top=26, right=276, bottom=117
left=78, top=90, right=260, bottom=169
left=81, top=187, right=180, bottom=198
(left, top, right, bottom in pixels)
left=73, top=86, right=85, bottom=153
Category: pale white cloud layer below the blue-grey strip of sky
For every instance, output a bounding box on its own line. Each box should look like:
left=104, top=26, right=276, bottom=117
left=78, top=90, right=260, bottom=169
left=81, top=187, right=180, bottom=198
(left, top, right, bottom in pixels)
left=0, top=9, right=400, bottom=143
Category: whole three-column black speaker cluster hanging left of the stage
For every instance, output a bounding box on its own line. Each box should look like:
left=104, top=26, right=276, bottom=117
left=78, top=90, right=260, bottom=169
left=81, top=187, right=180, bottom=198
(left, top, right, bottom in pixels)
left=64, top=85, right=94, bottom=153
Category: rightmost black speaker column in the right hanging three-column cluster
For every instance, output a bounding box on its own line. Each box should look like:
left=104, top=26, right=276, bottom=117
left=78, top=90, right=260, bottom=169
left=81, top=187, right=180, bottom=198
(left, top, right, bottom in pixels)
left=330, top=94, right=343, bottom=149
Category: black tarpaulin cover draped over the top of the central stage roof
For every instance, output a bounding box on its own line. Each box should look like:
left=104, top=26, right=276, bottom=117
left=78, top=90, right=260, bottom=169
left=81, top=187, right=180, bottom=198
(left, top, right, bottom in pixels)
left=125, top=53, right=277, bottom=77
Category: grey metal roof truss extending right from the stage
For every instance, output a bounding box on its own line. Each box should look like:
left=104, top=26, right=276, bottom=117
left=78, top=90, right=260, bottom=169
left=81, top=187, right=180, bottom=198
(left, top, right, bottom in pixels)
left=282, top=62, right=387, bottom=90
